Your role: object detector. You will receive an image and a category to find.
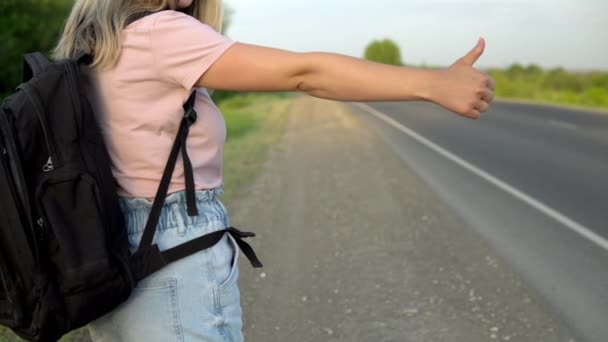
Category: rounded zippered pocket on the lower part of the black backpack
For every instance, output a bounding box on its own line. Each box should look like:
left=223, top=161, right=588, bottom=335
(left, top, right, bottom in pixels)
left=36, top=170, right=110, bottom=293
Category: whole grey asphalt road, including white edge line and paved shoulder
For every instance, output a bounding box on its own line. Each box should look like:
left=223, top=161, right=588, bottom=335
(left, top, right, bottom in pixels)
left=352, top=103, right=608, bottom=342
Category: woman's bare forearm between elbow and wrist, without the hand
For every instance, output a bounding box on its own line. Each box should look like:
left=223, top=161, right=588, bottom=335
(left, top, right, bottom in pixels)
left=297, top=53, right=434, bottom=102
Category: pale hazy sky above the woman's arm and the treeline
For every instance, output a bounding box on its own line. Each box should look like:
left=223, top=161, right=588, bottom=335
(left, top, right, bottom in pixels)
left=225, top=0, right=608, bottom=71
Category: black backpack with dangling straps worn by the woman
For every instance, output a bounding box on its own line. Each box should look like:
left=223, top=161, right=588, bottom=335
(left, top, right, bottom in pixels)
left=0, top=40, right=262, bottom=341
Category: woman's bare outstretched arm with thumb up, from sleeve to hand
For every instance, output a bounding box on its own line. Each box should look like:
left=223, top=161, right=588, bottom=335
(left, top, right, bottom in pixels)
left=197, top=40, right=494, bottom=118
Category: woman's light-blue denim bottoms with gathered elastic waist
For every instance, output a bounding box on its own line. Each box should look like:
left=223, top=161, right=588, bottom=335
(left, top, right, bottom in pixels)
left=88, top=188, right=243, bottom=342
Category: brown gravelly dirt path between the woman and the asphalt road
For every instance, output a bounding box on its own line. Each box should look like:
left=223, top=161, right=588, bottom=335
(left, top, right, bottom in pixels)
left=229, top=97, right=578, bottom=342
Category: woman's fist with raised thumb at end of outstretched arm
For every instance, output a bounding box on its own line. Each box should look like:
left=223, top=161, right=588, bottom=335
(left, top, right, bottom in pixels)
left=429, top=38, right=495, bottom=119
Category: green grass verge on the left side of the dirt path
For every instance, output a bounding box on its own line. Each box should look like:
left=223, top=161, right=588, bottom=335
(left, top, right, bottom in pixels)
left=0, top=94, right=292, bottom=342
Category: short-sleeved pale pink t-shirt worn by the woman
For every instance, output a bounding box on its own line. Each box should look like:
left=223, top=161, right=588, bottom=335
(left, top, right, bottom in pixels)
left=98, top=11, right=235, bottom=198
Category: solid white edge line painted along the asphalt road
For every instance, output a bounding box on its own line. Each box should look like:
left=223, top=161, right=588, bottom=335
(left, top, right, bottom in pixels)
left=353, top=103, right=608, bottom=251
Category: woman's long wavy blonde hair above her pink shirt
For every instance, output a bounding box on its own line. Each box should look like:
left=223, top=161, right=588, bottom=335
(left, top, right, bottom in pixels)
left=53, top=0, right=222, bottom=68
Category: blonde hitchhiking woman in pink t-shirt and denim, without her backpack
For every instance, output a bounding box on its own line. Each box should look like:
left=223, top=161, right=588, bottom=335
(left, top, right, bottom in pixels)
left=55, top=0, right=494, bottom=342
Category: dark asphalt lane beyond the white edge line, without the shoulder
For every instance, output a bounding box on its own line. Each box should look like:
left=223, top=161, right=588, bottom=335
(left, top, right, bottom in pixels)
left=356, top=102, right=608, bottom=238
